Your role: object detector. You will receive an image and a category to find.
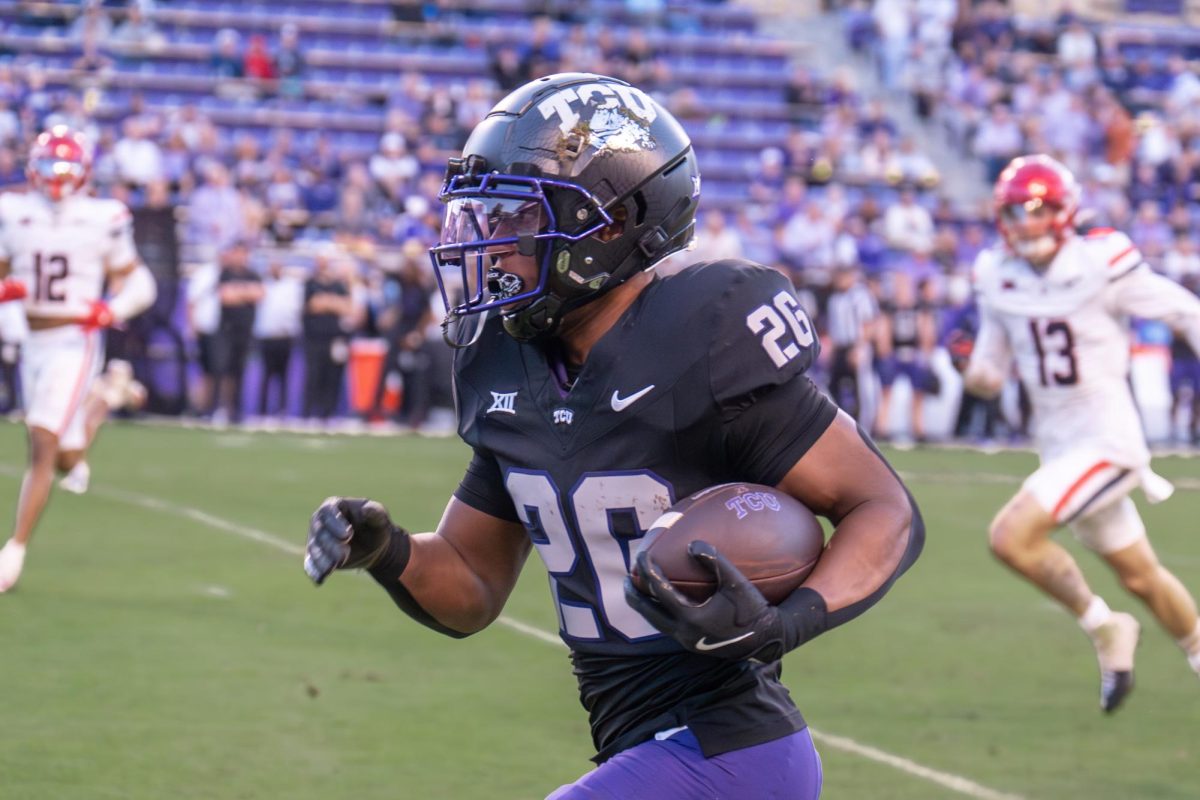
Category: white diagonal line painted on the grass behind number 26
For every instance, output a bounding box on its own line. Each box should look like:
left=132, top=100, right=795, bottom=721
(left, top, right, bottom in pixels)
left=0, top=464, right=1025, bottom=800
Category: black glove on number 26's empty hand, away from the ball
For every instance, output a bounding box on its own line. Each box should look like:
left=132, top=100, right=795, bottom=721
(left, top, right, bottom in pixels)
left=304, top=498, right=410, bottom=587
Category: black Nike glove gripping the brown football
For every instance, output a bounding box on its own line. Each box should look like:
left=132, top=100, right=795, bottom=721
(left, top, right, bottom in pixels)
left=625, top=541, right=786, bottom=662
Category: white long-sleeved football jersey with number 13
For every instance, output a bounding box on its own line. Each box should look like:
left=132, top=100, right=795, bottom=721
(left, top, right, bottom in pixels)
left=972, top=229, right=1200, bottom=467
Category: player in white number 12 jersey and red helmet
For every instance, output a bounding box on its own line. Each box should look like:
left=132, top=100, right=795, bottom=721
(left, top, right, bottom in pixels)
left=0, top=126, right=156, bottom=593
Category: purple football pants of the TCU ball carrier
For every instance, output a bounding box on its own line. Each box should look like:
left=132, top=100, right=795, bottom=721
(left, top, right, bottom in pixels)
left=546, top=728, right=821, bottom=800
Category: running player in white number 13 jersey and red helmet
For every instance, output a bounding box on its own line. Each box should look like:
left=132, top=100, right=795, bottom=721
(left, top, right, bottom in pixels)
left=965, top=156, right=1200, bottom=711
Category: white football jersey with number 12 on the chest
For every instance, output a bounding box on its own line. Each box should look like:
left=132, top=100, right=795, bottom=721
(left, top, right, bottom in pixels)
left=0, top=192, right=138, bottom=318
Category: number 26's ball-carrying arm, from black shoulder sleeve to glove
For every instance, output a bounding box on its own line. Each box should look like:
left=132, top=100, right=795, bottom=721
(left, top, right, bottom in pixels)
left=625, top=266, right=924, bottom=661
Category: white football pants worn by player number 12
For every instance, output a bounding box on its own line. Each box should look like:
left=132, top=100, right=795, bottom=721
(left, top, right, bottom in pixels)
left=20, top=325, right=104, bottom=450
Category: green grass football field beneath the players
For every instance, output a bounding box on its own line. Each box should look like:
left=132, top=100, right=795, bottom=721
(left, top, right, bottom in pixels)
left=0, top=423, right=1200, bottom=800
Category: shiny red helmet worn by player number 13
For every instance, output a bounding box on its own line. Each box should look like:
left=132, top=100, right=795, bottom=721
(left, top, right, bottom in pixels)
left=992, top=155, right=1080, bottom=266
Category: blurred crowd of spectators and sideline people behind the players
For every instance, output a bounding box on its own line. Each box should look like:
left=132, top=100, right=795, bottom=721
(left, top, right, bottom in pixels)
left=0, top=0, right=1200, bottom=438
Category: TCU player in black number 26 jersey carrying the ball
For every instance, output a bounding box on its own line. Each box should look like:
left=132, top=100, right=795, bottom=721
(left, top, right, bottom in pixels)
left=305, top=73, right=924, bottom=800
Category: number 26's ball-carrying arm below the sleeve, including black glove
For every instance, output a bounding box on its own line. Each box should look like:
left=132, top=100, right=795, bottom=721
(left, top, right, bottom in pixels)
left=625, top=393, right=925, bottom=661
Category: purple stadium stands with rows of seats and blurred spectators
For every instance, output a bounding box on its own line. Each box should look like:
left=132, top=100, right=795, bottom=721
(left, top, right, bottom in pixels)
left=0, top=0, right=1200, bottom=443
